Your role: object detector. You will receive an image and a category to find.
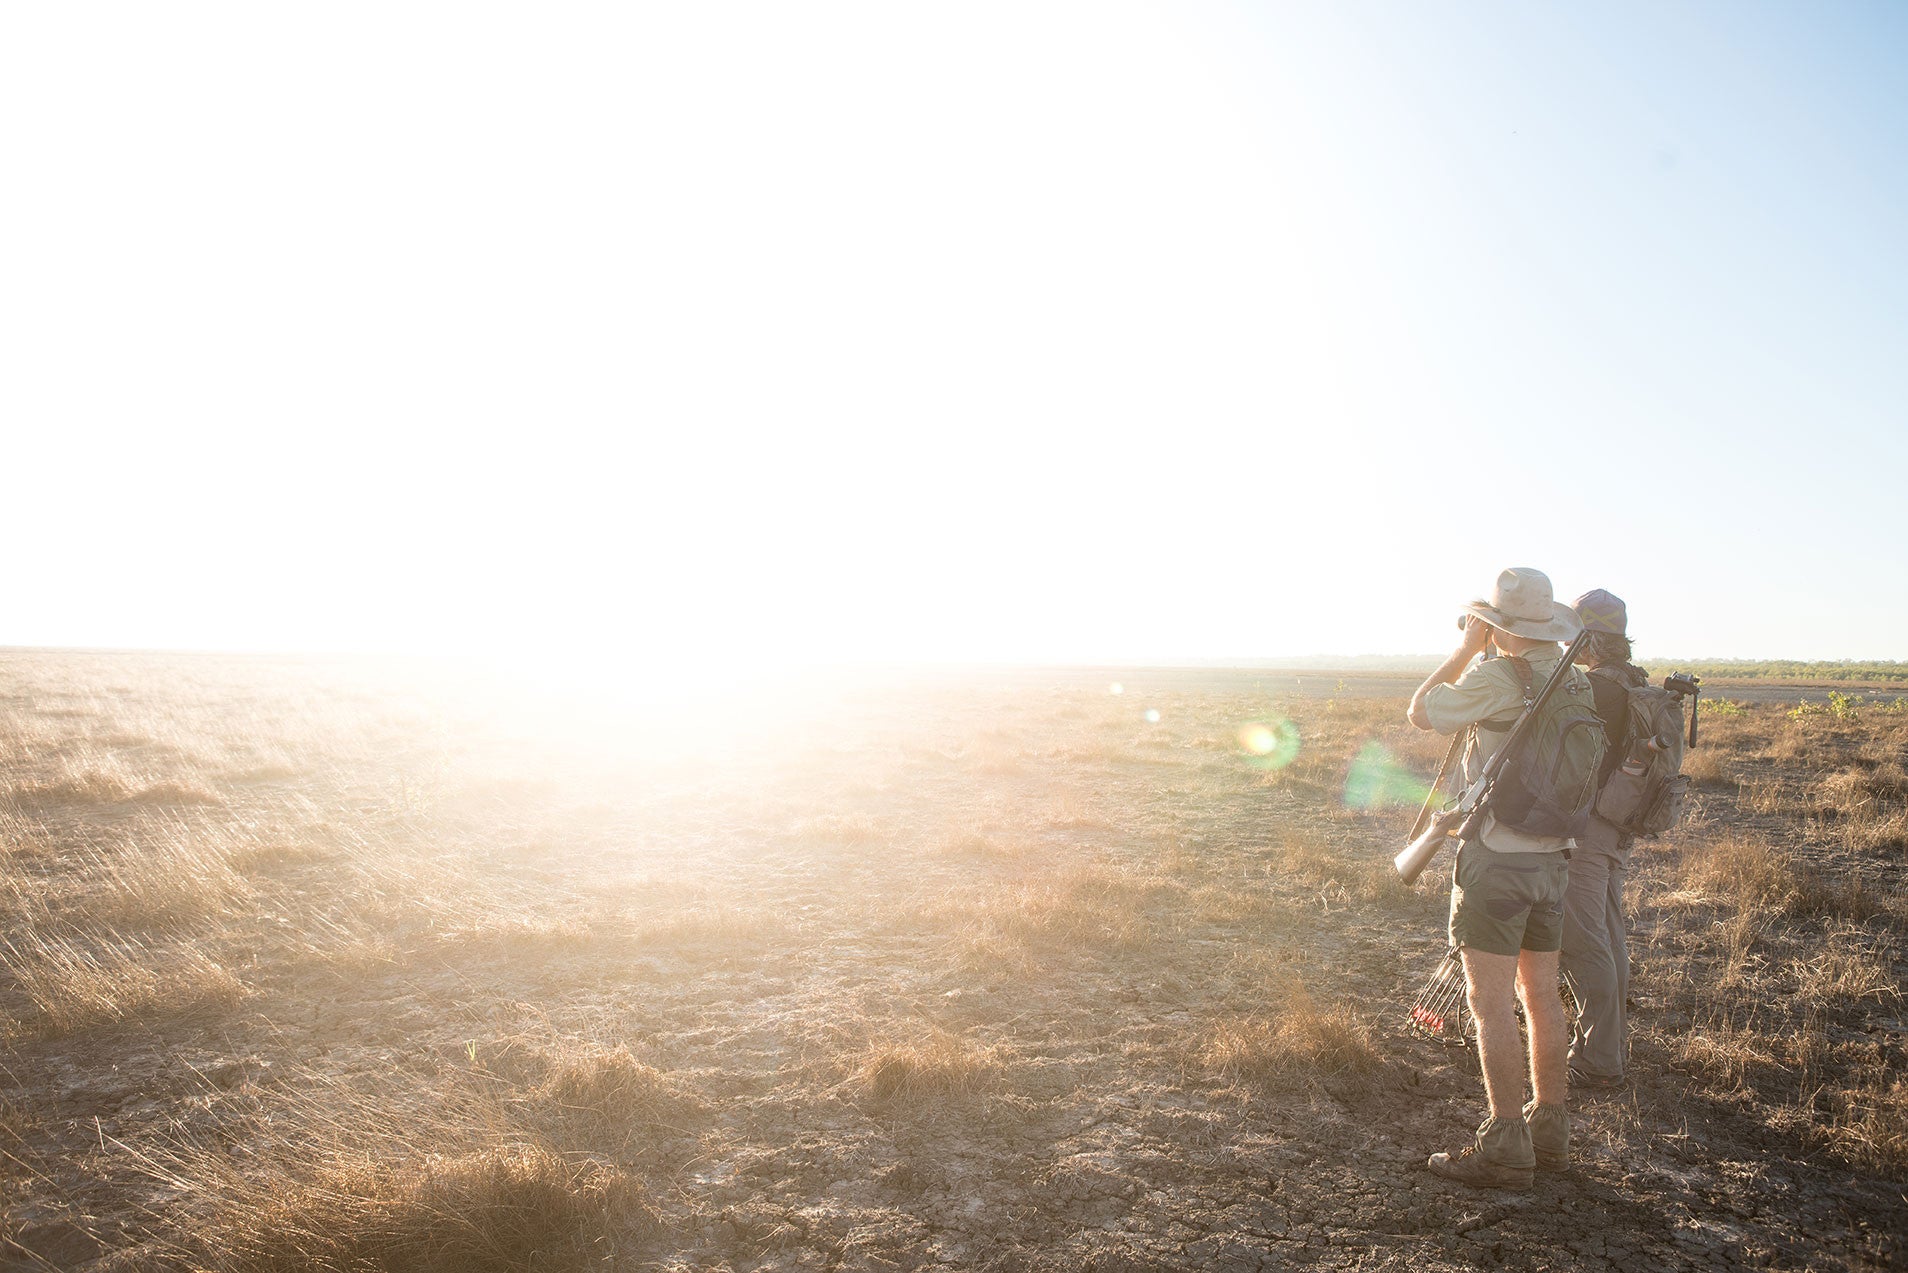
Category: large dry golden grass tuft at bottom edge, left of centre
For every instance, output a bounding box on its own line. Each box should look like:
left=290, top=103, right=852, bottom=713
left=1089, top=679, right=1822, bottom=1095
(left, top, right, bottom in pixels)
left=139, top=1071, right=653, bottom=1273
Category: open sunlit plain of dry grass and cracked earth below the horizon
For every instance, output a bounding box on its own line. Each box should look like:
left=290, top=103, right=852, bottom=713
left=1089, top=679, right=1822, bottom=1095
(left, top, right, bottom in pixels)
left=0, top=653, right=1908, bottom=1273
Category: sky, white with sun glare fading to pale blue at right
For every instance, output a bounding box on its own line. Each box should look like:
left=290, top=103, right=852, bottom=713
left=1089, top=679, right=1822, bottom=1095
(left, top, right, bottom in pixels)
left=0, top=0, right=1908, bottom=666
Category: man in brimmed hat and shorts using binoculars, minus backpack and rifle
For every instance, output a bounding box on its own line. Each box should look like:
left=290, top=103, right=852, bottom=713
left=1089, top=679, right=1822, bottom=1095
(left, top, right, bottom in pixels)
left=1408, top=567, right=1593, bottom=1187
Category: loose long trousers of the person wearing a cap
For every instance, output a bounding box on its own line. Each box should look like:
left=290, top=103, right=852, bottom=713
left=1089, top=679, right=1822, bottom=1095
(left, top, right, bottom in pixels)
left=1563, top=815, right=1631, bottom=1078
